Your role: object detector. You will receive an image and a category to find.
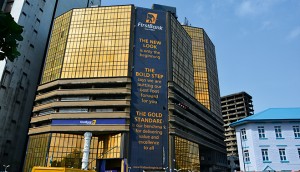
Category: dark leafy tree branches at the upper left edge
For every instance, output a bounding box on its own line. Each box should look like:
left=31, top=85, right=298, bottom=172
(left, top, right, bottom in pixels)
left=0, top=11, right=23, bottom=61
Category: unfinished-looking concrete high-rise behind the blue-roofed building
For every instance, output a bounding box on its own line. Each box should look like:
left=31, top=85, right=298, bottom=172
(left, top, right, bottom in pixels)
left=221, top=92, right=254, bottom=171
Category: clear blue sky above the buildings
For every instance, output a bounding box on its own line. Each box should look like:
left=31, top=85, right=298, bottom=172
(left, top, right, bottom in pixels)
left=0, top=0, right=300, bottom=113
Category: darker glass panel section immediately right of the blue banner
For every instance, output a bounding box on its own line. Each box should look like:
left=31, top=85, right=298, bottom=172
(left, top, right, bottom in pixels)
left=171, top=16, right=195, bottom=96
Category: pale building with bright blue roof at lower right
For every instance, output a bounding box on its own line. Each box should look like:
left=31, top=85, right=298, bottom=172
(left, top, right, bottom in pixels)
left=230, top=107, right=300, bottom=171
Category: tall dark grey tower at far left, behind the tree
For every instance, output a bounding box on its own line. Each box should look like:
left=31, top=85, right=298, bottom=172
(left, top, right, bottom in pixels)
left=0, top=0, right=100, bottom=171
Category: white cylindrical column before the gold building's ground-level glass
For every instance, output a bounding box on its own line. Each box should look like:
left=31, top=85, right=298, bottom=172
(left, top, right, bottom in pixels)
left=81, top=132, right=92, bottom=170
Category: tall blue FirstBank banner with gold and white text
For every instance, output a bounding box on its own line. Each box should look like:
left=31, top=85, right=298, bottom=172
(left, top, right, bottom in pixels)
left=128, top=8, right=168, bottom=171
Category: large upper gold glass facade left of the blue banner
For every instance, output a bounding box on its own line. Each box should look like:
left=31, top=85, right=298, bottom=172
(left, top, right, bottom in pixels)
left=42, top=6, right=132, bottom=83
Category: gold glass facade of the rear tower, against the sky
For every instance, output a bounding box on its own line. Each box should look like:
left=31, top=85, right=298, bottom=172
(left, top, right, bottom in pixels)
left=183, top=26, right=221, bottom=116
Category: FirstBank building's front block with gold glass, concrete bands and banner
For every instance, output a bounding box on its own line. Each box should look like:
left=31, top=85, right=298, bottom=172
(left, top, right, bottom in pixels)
left=24, top=5, right=226, bottom=172
